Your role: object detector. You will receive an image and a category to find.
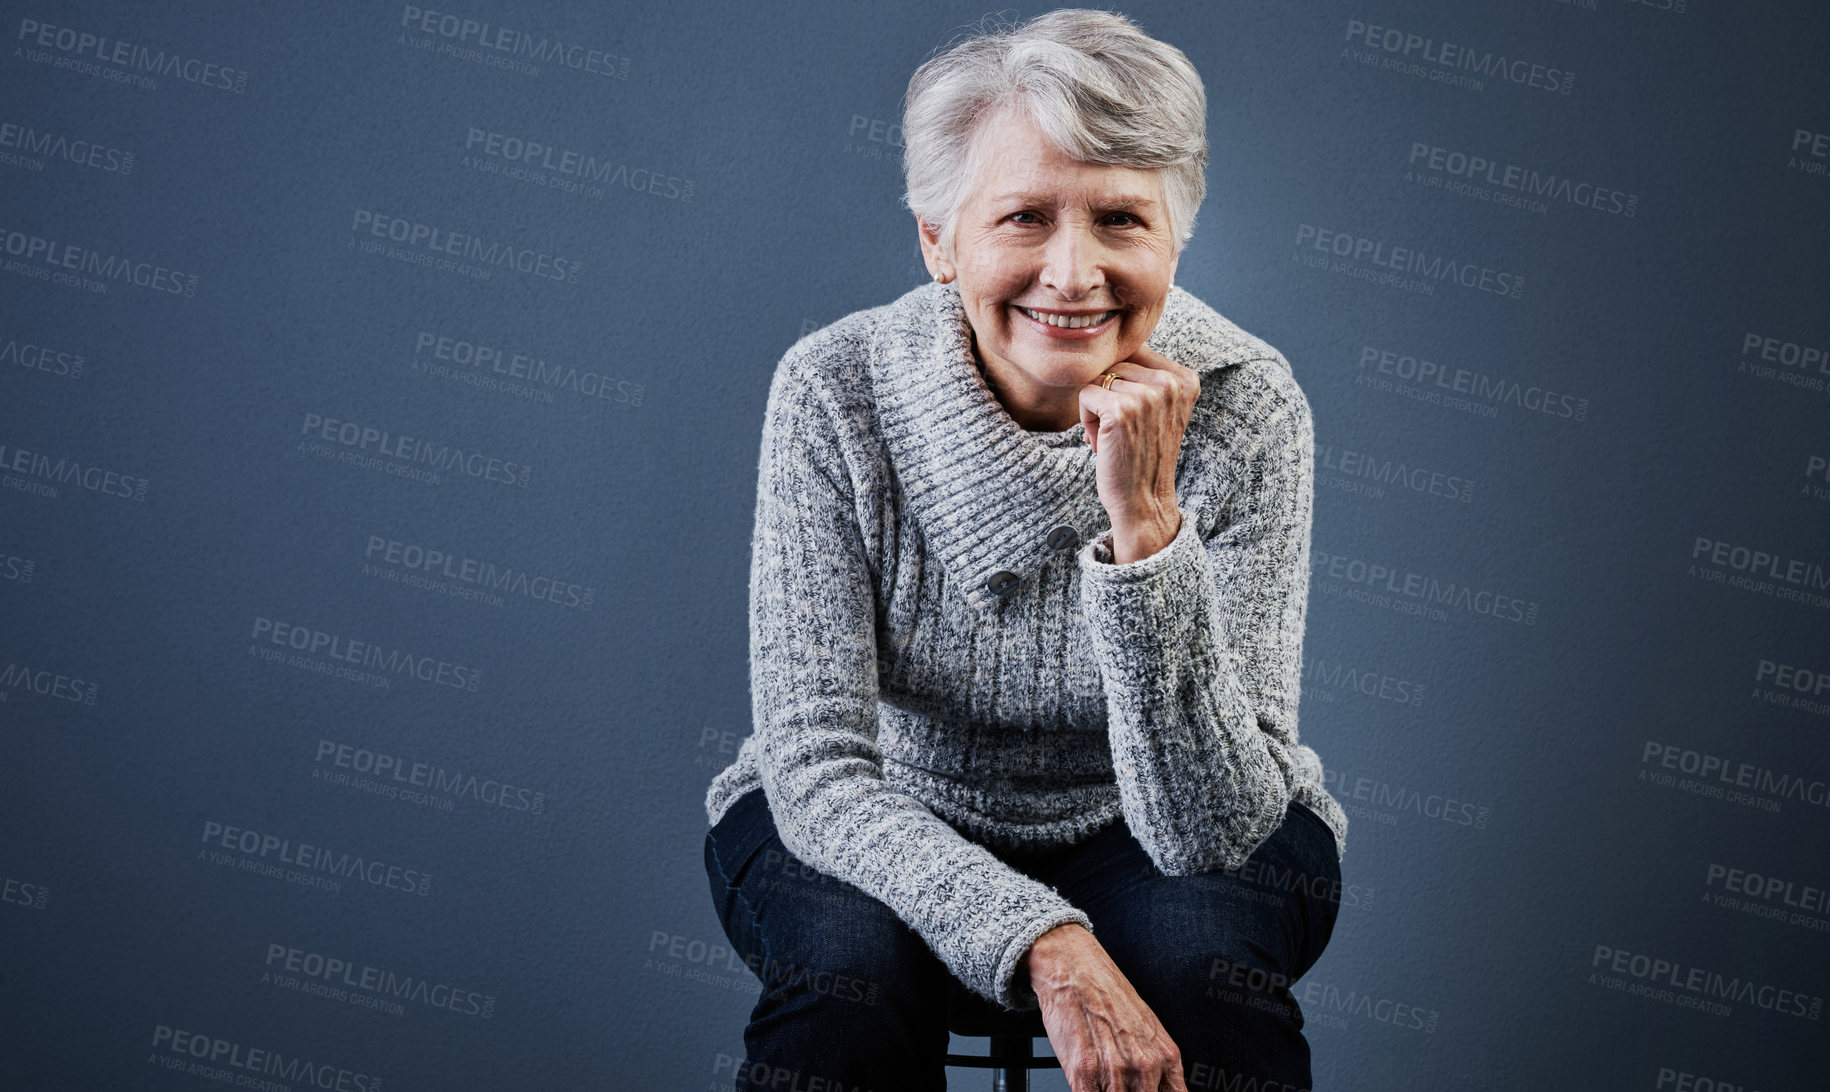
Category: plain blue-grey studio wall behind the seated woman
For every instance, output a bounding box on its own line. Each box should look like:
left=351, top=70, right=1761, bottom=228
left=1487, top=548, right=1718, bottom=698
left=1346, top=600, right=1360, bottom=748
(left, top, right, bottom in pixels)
left=0, top=0, right=1830, bottom=1092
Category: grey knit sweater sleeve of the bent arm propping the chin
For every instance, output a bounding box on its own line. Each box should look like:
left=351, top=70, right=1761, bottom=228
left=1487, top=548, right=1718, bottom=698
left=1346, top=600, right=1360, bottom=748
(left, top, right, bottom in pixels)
left=1078, top=378, right=1321, bottom=876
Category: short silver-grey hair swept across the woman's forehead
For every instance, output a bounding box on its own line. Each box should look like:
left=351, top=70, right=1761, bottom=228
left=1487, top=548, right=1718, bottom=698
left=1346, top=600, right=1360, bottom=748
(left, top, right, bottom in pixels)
left=902, top=7, right=1208, bottom=251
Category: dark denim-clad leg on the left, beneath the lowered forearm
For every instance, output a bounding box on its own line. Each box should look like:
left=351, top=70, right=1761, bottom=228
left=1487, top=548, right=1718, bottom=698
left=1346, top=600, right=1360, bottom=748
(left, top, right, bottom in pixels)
left=705, top=790, right=952, bottom=1092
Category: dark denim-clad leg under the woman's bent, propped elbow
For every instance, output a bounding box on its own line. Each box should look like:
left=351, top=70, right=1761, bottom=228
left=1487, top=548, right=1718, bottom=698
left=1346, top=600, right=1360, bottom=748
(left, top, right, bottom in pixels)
left=1050, top=805, right=1340, bottom=1090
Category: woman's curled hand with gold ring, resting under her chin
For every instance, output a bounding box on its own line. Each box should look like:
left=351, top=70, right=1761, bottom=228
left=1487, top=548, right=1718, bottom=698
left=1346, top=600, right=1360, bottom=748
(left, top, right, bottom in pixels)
left=1080, top=346, right=1200, bottom=565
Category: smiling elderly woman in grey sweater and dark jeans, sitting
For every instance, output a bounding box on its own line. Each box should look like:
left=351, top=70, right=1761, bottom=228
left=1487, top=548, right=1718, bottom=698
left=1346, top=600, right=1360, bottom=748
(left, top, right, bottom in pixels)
left=705, top=11, right=1347, bottom=1092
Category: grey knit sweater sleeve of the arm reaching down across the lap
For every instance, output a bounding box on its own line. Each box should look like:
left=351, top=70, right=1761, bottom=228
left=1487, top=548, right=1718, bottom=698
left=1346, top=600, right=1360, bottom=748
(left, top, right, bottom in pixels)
left=750, top=362, right=1093, bottom=1008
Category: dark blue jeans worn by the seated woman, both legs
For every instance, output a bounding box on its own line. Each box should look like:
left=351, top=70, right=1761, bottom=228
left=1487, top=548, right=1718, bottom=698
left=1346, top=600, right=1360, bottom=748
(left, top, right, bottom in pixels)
left=705, top=788, right=1341, bottom=1092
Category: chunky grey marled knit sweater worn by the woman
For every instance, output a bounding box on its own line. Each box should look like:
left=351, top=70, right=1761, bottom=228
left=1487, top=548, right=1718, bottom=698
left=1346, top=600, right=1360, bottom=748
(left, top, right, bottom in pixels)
left=705, top=276, right=1347, bottom=1008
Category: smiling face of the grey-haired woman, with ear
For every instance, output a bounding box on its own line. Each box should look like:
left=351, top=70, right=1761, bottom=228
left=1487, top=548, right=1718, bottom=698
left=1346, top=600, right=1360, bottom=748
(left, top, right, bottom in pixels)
left=920, top=110, right=1177, bottom=420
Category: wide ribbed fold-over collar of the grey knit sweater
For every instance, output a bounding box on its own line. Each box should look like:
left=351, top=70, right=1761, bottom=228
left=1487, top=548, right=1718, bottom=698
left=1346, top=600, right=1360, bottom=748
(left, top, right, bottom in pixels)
left=869, top=284, right=1255, bottom=615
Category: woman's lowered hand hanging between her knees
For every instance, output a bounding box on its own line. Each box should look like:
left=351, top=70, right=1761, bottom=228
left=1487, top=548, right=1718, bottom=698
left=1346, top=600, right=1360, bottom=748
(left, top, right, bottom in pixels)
left=1023, top=922, right=1188, bottom=1092
